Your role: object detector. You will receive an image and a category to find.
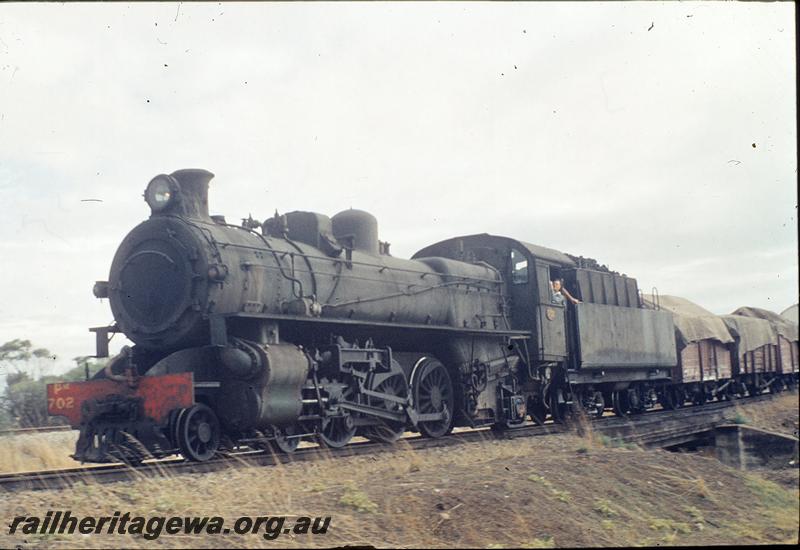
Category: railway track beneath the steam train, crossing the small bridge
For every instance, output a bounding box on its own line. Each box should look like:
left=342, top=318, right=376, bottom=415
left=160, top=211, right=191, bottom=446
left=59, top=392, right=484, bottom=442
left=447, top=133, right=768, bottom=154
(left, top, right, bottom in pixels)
left=0, top=394, right=788, bottom=492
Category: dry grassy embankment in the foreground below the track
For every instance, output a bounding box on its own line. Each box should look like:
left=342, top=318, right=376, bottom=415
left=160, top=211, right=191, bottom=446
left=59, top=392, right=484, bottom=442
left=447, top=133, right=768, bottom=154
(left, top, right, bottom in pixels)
left=0, top=395, right=800, bottom=548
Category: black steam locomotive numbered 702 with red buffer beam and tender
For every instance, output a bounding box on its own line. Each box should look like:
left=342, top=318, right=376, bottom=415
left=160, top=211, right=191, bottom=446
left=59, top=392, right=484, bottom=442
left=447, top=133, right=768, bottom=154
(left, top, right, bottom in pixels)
left=48, top=169, right=797, bottom=462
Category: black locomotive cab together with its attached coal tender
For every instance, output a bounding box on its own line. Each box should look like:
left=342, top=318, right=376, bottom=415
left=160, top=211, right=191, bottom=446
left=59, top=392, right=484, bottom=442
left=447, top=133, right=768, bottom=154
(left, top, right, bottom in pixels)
left=416, top=234, right=676, bottom=419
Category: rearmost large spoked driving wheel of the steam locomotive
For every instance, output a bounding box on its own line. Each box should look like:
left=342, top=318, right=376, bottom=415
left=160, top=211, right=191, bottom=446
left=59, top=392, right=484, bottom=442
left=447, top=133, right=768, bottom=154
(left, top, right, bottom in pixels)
left=412, top=358, right=455, bottom=438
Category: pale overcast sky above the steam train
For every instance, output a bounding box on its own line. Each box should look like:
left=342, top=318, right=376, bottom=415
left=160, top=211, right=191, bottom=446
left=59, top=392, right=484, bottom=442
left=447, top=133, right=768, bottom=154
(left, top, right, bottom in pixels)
left=0, top=2, right=798, bottom=378
